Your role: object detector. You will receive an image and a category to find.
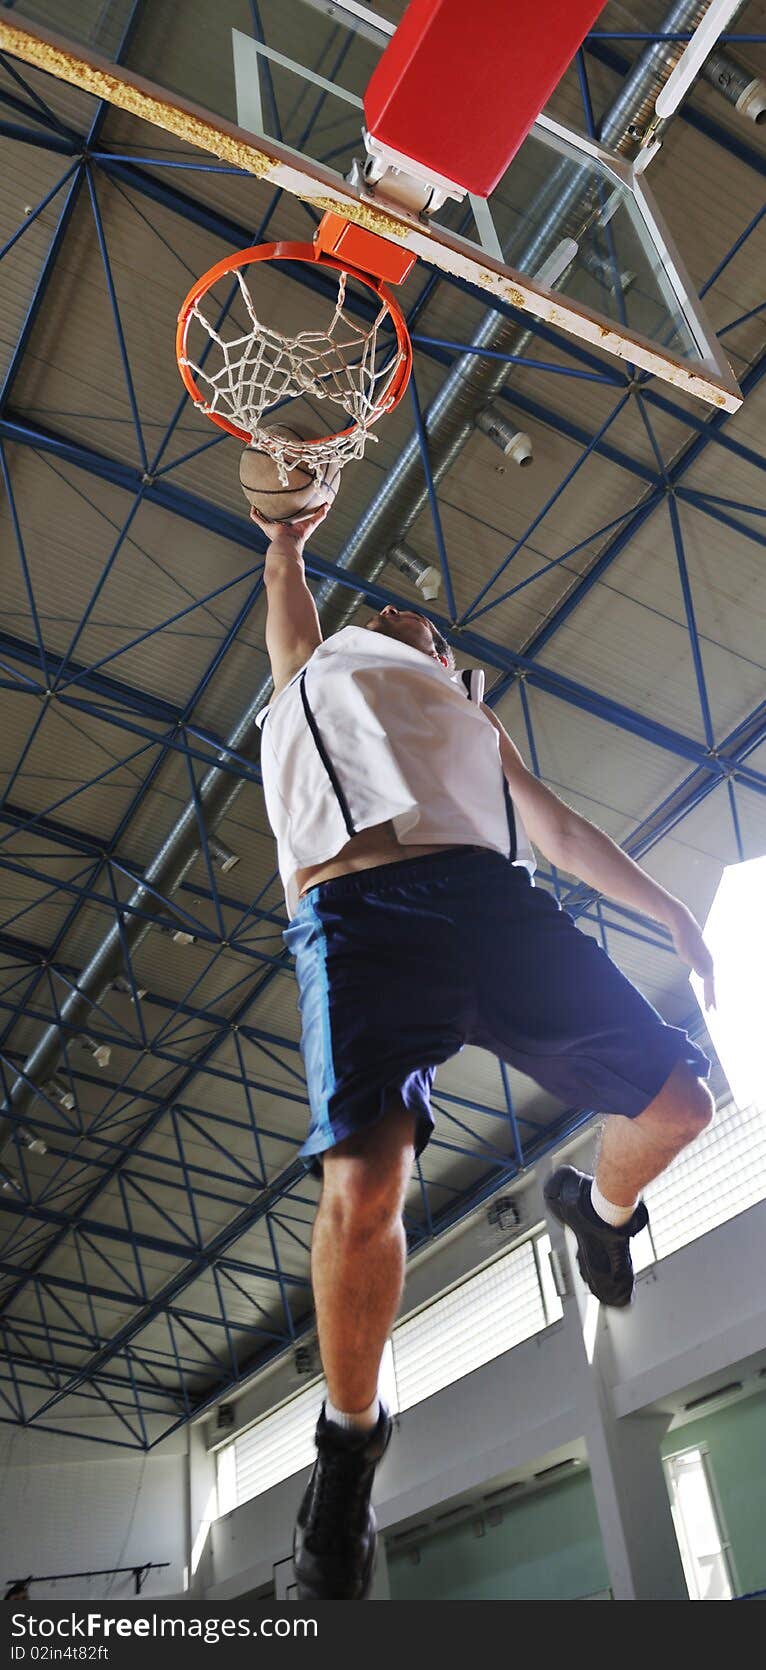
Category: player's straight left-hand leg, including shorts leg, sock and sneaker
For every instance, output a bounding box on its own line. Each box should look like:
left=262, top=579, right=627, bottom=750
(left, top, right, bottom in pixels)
left=285, top=852, right=471, bottom=1600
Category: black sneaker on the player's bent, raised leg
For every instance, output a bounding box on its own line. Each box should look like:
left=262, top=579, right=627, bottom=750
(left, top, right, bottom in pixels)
left=542, top=1166, right=649, bottom=1304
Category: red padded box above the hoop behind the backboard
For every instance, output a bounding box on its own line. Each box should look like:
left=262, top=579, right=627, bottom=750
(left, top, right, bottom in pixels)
left=364, top=0, right=604, bottom=197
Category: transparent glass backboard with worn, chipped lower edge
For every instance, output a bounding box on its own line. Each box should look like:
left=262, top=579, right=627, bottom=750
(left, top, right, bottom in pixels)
left=0, top=0, right=741, bottom=411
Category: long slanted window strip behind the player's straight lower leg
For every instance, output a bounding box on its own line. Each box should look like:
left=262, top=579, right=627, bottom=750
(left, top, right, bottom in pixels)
left=217, top=1234, right=561, bottom=1513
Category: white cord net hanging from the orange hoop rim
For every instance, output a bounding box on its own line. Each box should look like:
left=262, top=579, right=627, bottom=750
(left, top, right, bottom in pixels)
left=180, top=271, right=402, bottom=486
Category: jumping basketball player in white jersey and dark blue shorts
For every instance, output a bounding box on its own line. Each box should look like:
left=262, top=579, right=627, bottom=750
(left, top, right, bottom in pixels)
left=254, top=506, right=714, bottom=1600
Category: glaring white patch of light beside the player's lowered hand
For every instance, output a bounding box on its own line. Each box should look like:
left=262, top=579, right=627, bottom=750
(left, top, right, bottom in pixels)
left=689, top=853, right=766, bottom=1107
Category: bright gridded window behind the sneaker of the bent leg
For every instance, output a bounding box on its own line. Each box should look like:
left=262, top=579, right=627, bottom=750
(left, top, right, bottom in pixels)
left=632, top=1102, right=766, bottom=1271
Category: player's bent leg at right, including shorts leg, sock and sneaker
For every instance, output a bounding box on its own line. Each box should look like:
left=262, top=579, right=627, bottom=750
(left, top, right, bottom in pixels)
left=471, top=855, right=713, bottom=1306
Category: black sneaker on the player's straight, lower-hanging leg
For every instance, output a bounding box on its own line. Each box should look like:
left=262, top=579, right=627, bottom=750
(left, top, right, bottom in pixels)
left=292, top=1404, right=392, bottom=1600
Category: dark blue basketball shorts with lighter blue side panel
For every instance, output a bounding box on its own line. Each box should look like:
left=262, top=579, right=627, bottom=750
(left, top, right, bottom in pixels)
left=284, top=847, right=709, bottom=1169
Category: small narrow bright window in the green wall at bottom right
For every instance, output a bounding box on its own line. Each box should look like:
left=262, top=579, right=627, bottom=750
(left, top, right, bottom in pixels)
left=664, top=1450, right=734, bottom=1600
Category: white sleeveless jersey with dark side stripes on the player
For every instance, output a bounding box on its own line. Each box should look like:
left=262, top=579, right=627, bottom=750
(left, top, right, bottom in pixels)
left=255, top=626, right=534, bottom=917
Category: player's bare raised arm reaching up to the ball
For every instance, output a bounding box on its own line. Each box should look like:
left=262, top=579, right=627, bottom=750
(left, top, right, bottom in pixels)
left=250, top=504, right=329, bottom=696
